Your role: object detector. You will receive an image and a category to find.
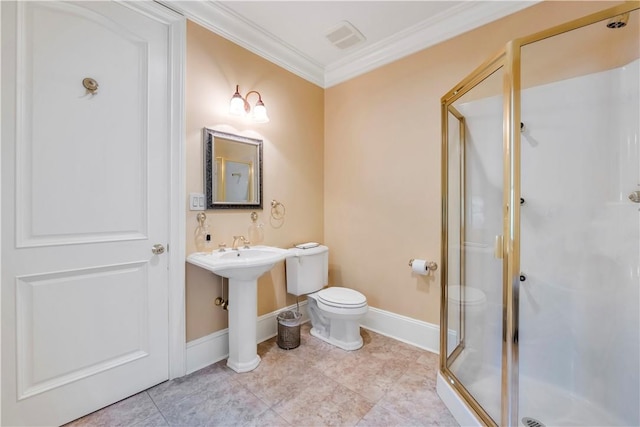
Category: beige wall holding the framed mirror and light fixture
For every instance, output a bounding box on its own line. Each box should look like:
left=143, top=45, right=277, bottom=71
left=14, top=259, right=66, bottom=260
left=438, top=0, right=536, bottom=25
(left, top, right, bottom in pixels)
left=185, top=22, right=324, bottom=341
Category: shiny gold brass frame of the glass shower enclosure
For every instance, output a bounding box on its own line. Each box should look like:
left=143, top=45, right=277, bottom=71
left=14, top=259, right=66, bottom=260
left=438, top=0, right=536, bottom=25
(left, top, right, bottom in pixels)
left=440, top=1, right=640, bottom=426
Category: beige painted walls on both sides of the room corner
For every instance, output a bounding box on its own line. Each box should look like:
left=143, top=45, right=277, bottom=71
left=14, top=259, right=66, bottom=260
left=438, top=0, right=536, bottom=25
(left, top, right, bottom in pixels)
left=185, top=1, right=620, bottom=341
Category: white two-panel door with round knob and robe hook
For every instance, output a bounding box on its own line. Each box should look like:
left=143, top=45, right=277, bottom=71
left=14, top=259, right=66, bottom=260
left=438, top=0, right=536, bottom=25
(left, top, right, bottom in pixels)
left=2, top=1, right=178, bottom=425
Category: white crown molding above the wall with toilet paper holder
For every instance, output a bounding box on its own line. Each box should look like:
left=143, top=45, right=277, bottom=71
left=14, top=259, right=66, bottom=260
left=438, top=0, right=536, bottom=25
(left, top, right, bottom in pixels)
left=324, top=1, right=538, bottom=88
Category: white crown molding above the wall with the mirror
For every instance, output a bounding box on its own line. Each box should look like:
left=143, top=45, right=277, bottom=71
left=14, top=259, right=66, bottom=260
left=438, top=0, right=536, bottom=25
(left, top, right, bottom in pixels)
left=165, top=0, right=324, bottom=87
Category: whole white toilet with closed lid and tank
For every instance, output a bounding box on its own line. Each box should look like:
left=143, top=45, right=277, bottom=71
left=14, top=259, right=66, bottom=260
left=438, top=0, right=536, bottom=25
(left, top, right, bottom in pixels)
left=286, top=244, right=369, bottom=350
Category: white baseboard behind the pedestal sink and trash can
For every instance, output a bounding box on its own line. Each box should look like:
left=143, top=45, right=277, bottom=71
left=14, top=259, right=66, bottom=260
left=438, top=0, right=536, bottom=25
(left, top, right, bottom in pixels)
left=186, top=301, right=309, bottom=374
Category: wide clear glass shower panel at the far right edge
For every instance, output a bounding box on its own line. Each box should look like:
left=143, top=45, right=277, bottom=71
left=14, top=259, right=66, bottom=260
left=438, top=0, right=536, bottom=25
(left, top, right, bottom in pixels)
left=518, top=11, right=640, bottom=426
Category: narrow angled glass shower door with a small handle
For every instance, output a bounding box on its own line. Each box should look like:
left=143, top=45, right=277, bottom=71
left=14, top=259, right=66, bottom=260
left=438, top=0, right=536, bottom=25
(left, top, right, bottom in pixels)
left=446, top=68, right=503, bottom=421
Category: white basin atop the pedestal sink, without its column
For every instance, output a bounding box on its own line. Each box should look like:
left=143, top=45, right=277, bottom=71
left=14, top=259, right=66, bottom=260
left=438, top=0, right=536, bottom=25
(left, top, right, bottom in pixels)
left=187, top=246, right=289, bottom=280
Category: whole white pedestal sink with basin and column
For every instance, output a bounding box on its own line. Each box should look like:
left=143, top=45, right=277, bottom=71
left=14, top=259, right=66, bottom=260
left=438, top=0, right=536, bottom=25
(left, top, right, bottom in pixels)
left=187, top=246, right=289, bottom=372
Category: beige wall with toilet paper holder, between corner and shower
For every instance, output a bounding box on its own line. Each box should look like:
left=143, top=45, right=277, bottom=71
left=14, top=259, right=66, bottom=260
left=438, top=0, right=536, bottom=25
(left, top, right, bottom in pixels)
left=324, top=2, right=619, bottom=324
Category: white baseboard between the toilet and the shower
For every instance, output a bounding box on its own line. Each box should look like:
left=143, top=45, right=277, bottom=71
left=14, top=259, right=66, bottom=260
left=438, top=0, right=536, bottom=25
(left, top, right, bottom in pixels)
left=360, top=307, right=440, bottom=353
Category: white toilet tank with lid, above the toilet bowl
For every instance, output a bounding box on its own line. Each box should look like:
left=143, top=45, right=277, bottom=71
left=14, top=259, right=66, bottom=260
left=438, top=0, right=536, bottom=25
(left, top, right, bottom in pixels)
left=286, top=245, right=329, bottom=295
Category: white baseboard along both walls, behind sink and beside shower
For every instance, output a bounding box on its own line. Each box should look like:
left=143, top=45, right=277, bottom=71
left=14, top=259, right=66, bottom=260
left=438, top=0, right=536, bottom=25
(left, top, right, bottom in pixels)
left=187, top=301, right=440, bottom=374
